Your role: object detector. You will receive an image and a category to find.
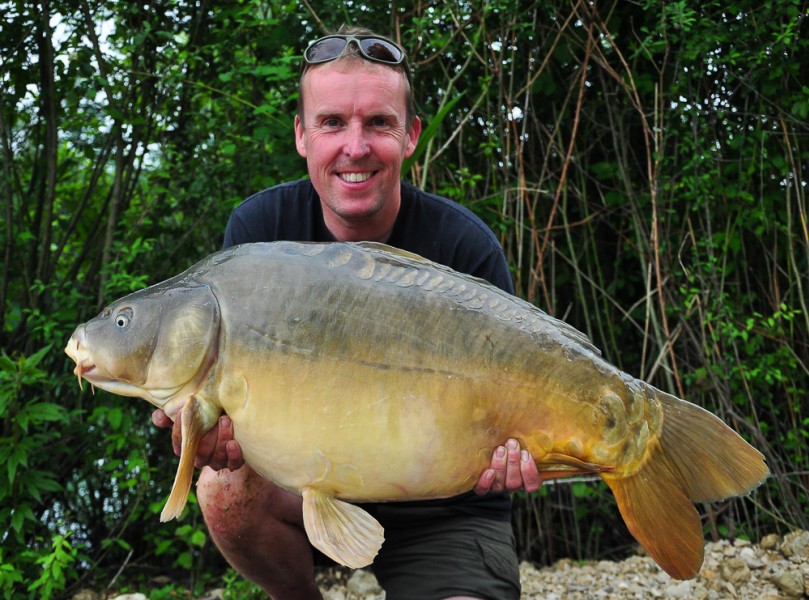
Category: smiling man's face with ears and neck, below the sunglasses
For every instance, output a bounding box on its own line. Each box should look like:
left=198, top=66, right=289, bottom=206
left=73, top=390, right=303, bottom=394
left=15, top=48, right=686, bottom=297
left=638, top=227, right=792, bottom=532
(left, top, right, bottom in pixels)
left=295, top=59, right=421, bottom=241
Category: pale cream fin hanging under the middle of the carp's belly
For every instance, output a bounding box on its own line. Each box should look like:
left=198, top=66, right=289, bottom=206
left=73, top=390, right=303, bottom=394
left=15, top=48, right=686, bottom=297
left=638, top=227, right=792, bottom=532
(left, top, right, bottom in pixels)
left=303, top=488, right=385, bottom=569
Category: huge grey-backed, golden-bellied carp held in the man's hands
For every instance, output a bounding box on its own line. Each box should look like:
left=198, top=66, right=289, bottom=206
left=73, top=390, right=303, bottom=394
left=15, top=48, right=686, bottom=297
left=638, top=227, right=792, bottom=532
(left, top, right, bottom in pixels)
left=66, top=242, right=768, bottom=578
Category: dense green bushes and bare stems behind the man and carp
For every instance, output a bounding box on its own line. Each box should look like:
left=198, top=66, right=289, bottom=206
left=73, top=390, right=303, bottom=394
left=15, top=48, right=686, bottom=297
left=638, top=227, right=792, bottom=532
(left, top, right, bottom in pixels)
left=0, top=0, right=809, bottom=598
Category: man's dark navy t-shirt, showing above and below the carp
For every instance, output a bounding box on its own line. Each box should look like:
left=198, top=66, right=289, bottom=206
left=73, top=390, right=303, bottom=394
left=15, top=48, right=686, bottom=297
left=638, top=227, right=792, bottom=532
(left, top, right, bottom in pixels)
left=224, top=179, right=514, bottom=525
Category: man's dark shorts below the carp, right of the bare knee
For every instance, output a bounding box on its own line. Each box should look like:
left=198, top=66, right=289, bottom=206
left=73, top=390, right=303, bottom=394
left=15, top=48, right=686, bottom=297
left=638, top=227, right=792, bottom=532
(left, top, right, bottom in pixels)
left=372, top=504, right=520, bottom=600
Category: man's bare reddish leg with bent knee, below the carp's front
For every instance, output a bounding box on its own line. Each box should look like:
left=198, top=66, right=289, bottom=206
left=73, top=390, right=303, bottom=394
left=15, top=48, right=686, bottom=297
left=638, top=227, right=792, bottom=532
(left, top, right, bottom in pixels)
left=197, top=465, right=322, bottom=600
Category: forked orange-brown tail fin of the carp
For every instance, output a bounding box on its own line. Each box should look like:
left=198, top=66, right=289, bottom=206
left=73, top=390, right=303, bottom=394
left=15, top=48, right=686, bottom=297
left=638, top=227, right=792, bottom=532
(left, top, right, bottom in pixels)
left=603, top=390, right=769, bottom=579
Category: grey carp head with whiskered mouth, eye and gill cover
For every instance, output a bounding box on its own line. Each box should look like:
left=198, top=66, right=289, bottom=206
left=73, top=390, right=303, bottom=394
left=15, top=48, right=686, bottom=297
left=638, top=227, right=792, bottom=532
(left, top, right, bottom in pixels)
left=65, top=280, right=220, bottom=416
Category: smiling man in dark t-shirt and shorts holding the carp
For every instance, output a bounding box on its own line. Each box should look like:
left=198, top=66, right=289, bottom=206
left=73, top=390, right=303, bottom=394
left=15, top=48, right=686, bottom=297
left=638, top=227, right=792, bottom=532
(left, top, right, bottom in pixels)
left=153, top=29, right=541, bottom=600
